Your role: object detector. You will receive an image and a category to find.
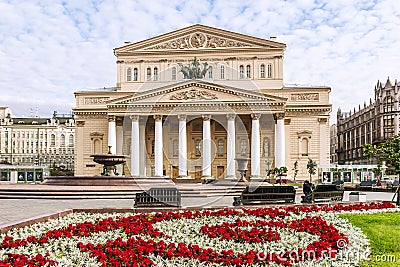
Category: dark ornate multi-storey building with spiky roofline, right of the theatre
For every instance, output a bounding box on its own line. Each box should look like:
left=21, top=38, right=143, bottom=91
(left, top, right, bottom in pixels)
left=337, top=78, right=400, bottom=164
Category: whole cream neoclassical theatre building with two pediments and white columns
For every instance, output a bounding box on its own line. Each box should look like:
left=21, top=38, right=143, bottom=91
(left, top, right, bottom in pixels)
left=74, top=25, right=331, bottom=179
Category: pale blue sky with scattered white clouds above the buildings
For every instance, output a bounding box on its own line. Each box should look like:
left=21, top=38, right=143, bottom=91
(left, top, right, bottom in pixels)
left=0, top=0, right=400, bottom=123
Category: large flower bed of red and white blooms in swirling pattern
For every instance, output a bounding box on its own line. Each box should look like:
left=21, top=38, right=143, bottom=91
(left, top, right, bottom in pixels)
left=0, top=203, right=399, bottom=267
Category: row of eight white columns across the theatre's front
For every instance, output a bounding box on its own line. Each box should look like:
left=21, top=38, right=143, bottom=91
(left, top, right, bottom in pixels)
left=108, top=113, right=285, bottom=179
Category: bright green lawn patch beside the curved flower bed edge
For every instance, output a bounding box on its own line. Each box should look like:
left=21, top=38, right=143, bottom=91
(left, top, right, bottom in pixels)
left=340, top=213, right=400, bottom=267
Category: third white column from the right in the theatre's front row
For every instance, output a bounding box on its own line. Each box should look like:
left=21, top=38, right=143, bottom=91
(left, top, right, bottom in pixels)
left=226, top=114, right=236, bottom=178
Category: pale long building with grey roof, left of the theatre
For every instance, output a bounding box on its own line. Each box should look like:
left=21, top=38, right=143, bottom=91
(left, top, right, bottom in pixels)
left=0, top=107, right=75, bottom=176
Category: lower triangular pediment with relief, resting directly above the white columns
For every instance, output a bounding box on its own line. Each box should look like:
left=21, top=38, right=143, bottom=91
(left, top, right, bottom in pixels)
left=107, top=80, right=287, bottom=105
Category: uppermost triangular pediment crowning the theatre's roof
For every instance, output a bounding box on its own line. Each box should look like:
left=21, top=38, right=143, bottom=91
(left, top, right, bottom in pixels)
left=114, top=24, right=286, bottom=55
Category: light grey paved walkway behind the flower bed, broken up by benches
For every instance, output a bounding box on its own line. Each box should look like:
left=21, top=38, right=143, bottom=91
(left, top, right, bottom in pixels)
left=0, top=184, right=393, bottom=228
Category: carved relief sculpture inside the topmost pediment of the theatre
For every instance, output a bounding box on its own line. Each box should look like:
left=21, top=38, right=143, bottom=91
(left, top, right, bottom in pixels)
left=145, top=32, right=254, bottom=50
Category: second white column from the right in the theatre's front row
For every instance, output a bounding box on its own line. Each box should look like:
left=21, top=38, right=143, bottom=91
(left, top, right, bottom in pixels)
left=251, top=114, right=261, bottom=178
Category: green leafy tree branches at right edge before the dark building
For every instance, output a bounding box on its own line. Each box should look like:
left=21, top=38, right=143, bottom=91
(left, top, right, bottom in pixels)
left=363, top=135, right=400, bottom=174
